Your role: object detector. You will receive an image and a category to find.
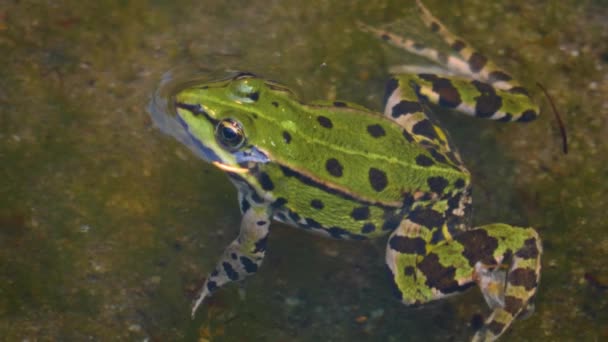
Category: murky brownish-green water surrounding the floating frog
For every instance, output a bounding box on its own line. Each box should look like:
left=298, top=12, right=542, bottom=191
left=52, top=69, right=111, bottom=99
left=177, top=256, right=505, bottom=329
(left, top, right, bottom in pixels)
left=0, top=0, right=608, bottom=341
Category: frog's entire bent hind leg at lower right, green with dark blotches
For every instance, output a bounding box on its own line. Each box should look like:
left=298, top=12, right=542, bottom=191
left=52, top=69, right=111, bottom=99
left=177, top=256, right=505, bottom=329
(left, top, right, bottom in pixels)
left=386, top=220, right=542, bottom=341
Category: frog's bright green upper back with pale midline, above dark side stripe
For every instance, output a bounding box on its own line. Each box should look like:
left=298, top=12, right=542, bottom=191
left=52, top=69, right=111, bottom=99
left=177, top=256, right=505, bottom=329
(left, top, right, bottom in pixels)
left=249, top=99, right=469, bottom=207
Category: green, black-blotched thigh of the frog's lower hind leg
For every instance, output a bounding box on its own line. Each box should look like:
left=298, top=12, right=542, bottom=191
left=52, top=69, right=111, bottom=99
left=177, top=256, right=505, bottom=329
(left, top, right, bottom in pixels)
left=386, top=220, right=474, bottom=305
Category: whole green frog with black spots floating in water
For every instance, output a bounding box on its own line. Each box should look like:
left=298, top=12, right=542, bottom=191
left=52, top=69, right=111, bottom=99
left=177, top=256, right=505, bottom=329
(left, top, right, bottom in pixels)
left=152, top=0, right=542, bottom=341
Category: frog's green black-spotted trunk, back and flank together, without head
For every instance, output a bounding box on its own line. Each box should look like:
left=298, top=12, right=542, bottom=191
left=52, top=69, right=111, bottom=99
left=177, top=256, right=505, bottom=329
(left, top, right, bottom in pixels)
left=247, top=97, right=469, bottom=239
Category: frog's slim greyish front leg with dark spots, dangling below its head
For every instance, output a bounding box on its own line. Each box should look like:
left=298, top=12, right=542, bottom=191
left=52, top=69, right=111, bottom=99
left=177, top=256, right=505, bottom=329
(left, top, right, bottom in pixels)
left=192, top=193, right=270, bottom=318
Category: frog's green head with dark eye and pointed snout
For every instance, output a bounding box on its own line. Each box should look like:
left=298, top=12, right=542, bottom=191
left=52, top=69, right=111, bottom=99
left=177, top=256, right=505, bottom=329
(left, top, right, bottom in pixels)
left=175, top=73, right=288, bottom=173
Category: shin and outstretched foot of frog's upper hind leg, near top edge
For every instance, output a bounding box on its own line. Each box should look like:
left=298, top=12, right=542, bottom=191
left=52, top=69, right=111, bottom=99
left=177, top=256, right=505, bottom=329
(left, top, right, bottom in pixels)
left=360, top=0, right=539, bottom=122
